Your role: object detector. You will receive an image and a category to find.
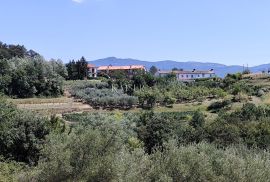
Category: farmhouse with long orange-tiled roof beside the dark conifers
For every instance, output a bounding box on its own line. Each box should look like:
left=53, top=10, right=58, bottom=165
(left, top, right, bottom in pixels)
left=87, top=64, right=146, bottom=78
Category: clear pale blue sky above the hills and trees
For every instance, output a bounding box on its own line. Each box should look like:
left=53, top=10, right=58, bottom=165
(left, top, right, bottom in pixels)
left=0, top=0, right=270, bottom=66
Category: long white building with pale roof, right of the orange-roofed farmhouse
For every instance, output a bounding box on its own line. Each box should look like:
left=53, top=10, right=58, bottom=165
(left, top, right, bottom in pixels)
left=157, top=69, right=216, bottom=81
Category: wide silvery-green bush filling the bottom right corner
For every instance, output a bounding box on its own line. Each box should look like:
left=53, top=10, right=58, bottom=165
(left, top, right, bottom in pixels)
left=149, top=143, right=270, bottom=181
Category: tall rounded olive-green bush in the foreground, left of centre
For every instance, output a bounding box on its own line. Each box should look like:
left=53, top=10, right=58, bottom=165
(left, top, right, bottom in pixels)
left=35, top=120, right=130, bottom=181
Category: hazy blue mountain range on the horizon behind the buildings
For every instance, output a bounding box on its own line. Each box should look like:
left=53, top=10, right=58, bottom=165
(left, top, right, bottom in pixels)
left=89, top=57, right=270, bottom=77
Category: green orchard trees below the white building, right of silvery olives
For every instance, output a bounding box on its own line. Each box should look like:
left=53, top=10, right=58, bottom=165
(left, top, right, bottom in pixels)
left=135, top=81, right=227, bottom=108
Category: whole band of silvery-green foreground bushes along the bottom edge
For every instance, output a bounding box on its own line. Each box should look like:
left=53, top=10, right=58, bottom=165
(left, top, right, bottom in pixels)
left=32, top=137, right=270, bottom=181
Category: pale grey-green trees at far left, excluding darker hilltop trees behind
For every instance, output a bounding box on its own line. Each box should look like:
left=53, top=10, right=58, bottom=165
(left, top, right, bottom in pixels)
left=0, top=57, right=64, bottom=98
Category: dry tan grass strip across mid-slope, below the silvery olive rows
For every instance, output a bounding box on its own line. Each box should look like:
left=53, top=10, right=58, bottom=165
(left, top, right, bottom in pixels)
left=8, top=97, right=211, bottom=114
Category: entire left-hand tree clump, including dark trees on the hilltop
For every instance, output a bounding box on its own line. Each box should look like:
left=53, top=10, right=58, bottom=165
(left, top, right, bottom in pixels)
left=0, top=42, right=67, bottom=98
